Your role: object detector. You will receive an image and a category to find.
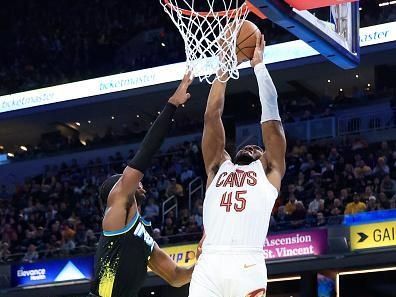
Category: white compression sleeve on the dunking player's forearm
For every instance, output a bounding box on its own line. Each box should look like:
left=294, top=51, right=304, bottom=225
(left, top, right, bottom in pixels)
left=254, top=63, right=281, bottom=123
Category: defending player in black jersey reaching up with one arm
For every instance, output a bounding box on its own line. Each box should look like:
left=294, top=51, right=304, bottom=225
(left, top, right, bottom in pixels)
left=90, top=73, right=193, bottom=297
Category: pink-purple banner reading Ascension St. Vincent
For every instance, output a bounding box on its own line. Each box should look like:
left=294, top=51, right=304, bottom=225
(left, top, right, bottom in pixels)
left=264, top=229, right=327, bottom=260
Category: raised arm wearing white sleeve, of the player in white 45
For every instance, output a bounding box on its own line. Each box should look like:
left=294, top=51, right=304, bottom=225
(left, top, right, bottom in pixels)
left=251, top=35, right=286, bottom=191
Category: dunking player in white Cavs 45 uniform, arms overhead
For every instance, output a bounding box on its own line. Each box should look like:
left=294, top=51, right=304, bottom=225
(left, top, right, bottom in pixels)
left=189, top=33, right=286, bottom=297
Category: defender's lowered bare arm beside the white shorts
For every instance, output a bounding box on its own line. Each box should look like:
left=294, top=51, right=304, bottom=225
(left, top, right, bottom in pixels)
left=148, top=243, right=194, bottom=287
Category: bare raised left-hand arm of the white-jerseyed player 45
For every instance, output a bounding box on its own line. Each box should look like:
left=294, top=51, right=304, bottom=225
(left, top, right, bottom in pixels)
left=202, top=76, right=230, bottom=185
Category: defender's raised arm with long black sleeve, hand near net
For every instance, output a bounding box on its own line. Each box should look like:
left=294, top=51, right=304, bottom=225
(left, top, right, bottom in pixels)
left=103, top=73, right=192, bottom=231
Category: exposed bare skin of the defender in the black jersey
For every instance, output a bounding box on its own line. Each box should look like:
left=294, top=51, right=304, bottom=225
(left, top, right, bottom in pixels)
left=102, top=73, right=199, bottom=287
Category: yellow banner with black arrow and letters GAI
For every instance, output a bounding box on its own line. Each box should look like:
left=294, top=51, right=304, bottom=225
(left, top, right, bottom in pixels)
left=350, top=220, right=396, bottom=251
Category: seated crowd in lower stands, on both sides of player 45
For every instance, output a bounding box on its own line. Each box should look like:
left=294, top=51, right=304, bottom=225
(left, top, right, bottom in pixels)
left=0, top=131, right=396, bottom=262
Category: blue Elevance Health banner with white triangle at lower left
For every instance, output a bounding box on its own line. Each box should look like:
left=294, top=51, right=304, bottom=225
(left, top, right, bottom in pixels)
left=11, top=256, right=94, bottom=287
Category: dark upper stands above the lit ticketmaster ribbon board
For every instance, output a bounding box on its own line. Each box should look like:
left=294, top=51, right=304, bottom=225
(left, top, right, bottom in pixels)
left=0, top=0, right=396, bottom=95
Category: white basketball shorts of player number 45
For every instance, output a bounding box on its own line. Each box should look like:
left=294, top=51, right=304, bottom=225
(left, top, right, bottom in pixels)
left=189, top=249, right=267, bottom=297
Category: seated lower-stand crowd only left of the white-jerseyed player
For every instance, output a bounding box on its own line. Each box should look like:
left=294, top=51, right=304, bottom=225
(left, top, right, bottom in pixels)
left=0, top=142, right=203, bottom=262
